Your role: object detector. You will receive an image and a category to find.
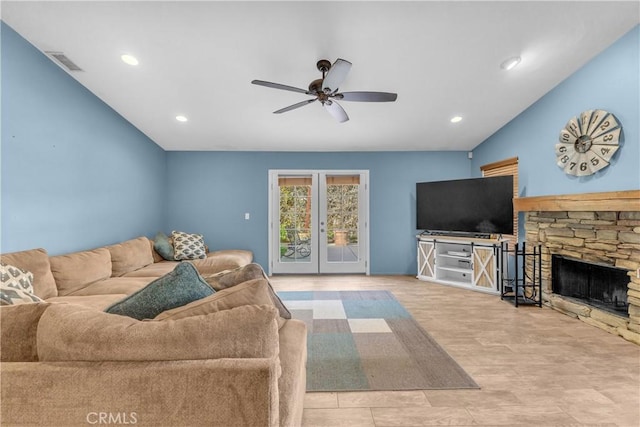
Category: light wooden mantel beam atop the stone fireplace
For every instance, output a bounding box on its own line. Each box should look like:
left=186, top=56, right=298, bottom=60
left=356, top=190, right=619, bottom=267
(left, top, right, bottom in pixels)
left=513, top=190, right=640, bottom=212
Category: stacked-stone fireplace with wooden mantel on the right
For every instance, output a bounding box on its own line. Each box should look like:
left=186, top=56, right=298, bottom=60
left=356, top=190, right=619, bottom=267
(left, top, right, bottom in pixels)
left=514, top=190, right=640, bottom=345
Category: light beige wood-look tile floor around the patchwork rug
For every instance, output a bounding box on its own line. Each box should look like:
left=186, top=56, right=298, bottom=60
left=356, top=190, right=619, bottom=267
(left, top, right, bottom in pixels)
left=271, top=275, right=640, bottom=427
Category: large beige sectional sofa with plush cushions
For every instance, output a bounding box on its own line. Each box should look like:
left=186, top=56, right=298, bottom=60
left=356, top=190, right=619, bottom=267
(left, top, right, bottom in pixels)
left=0, top=237, right=307, bottom=427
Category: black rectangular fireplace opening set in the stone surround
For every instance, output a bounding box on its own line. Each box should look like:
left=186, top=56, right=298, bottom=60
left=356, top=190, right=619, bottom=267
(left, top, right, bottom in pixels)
left=551, top=255, right=629, bottom=317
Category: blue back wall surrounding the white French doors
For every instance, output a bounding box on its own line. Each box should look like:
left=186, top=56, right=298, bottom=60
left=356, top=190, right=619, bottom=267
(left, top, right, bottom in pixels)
left=167, top=152, right=470, bottom=274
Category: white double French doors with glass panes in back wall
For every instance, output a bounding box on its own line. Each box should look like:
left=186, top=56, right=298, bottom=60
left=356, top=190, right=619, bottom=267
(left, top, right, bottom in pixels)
left=269, top=170, right=369, bottom=274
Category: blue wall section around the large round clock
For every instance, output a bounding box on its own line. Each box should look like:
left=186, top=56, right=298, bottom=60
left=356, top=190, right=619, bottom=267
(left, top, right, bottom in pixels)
left=472, top=26, right=640, bottom=196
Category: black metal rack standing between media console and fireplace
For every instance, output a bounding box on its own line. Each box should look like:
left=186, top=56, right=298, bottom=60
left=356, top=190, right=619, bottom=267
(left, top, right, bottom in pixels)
left=498, top=242, right=542, bottom=307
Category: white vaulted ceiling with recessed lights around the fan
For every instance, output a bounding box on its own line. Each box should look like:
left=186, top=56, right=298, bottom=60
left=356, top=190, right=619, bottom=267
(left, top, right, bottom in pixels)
left=1, top=1, right=640, bottom=151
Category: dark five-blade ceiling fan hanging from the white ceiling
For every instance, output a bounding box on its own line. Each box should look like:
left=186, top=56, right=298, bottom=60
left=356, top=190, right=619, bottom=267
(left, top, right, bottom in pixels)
left=251, top=58, right=398, bottom=123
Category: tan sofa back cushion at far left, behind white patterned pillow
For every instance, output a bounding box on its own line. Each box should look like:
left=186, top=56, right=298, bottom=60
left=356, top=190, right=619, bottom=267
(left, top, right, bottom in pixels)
left=2, top=248, right=58, bottom=299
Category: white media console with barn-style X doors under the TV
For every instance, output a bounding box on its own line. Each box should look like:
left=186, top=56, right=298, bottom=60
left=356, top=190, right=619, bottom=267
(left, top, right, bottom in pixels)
left=417, top=234, right=502, bottom=295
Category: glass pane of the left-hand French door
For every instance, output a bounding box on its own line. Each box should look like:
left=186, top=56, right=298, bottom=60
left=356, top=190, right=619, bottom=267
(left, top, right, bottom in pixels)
left=278, top=176, right=312, bottom=263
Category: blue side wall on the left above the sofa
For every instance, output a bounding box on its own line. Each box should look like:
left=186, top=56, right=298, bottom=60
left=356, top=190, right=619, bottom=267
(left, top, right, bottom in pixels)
left=0, top=23, right=166, bottom=254
